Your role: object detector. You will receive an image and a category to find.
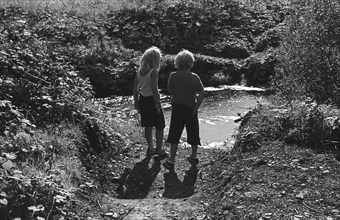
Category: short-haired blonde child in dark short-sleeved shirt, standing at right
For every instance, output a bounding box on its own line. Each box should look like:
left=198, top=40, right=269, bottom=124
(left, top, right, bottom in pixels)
left=163, top=50, right=204, bottom=170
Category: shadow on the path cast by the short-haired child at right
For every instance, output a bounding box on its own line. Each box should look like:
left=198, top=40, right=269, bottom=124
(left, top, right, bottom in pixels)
left=163, top=165, right=198, bottom=199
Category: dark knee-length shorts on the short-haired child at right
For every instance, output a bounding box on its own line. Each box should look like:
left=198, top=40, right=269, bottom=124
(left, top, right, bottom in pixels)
left=167, top=103, right=201, bottom=145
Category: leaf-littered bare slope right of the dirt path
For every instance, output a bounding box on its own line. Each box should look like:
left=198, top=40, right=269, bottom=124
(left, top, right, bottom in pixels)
left=203, top=142, right=340, bottom=220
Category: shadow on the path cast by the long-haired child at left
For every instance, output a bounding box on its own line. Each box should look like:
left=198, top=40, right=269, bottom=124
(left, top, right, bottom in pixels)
left=117, top=157, right=161, bottom=199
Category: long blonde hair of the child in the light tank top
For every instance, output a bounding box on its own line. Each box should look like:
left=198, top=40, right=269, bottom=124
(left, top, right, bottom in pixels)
left=138, top=46, right=162, bottom=73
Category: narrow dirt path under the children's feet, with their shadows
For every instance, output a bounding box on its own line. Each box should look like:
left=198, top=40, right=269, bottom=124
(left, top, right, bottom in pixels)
left=102, top=145, right=219, bottom=220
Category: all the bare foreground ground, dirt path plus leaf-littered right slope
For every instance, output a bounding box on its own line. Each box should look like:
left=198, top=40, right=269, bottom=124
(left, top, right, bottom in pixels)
left=77, top=138, right=340, bottom=220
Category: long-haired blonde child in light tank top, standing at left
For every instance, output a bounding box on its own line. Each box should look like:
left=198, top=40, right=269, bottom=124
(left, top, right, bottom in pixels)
left=133, top=46, right=167, bottom=159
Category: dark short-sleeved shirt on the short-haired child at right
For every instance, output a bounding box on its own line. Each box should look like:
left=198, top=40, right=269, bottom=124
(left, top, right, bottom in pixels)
left=168, top=71, right=204, bottom=108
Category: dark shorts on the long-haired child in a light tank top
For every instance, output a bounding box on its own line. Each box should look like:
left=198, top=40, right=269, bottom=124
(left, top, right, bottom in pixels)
left=139, top=95, right=165, bottom=130
